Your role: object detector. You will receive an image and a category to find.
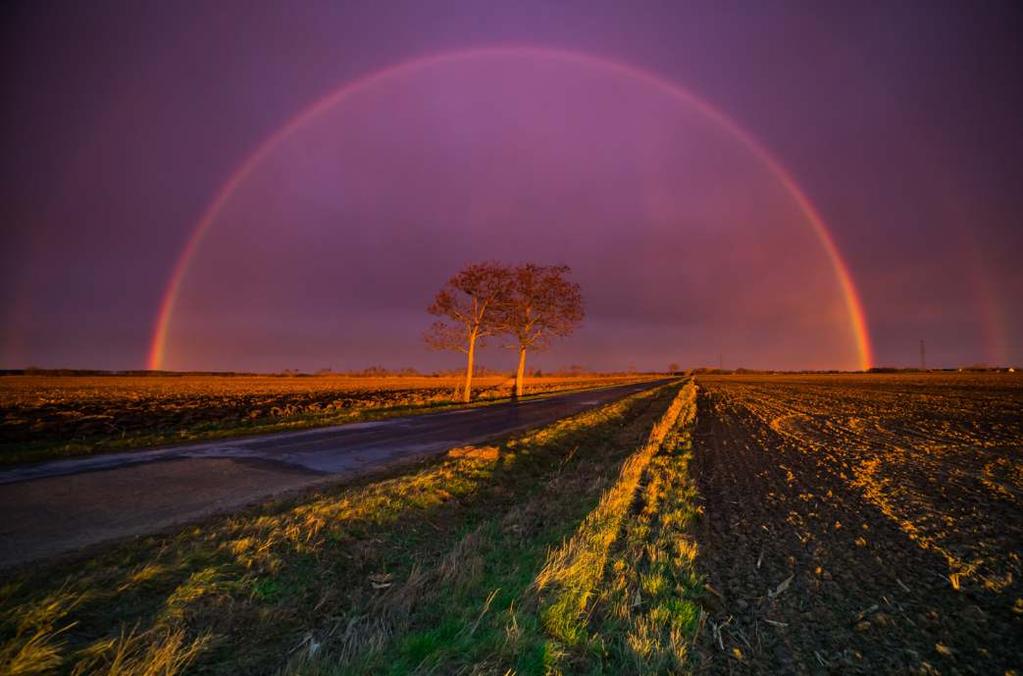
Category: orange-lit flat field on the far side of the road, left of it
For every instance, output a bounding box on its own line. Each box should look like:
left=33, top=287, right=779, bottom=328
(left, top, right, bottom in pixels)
left=0, top=374, right=642, bottom=464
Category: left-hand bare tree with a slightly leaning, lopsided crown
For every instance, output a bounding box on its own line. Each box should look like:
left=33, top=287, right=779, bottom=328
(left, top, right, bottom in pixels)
left=424, top=263, right=510, bottom=402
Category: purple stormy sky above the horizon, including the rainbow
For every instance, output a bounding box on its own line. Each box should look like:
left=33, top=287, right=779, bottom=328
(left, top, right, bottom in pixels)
left=0, top=0, right=1023, bottom=371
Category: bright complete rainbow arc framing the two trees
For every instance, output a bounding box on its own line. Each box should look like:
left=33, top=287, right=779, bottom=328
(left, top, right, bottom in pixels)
left=147, top=46, right=873, bottom=370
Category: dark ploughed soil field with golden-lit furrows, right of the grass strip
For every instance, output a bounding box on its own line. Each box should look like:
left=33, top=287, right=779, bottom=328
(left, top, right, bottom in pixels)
left=694, top=379, right=1023, bottom=673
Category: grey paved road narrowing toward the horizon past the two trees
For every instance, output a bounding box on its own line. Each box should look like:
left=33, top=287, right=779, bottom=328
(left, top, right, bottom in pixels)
left=0, top=380, right=664, bottom=567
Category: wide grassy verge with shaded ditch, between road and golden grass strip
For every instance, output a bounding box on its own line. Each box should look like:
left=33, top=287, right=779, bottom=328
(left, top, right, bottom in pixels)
left=0, top=387, right=677, bottom=674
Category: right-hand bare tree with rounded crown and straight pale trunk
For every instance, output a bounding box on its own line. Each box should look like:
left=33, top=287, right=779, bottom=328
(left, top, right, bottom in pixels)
left=496, top=263, right=583, bottom=397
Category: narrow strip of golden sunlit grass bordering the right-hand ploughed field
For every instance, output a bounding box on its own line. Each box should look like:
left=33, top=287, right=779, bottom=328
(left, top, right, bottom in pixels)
left=536, top=382, right=700, bottom=673
